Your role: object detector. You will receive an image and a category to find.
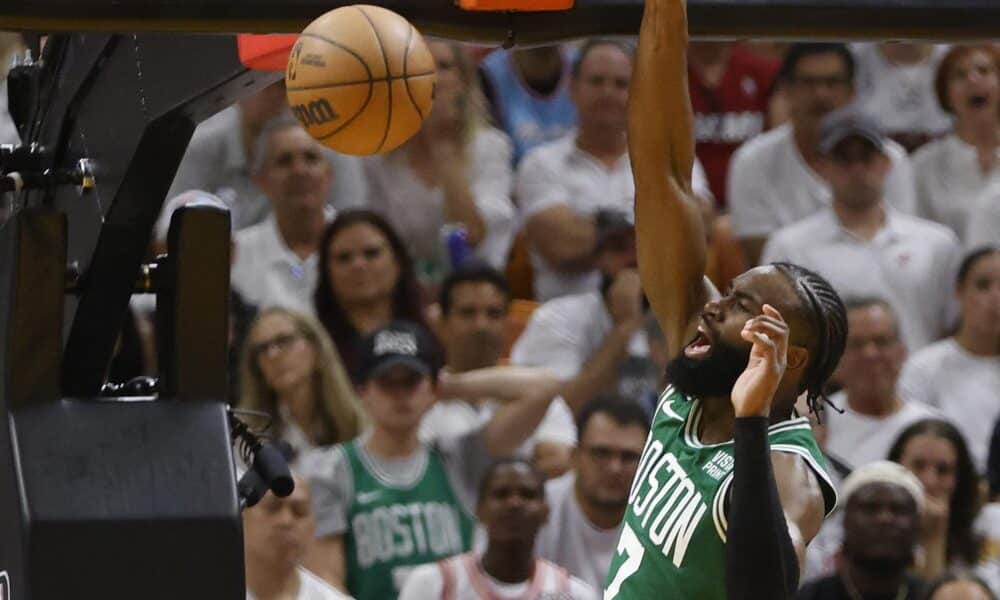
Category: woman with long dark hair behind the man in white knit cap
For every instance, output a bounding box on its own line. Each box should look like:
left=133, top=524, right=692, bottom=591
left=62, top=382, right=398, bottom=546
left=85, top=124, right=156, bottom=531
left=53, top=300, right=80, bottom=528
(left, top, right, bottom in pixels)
left=889, top=419, right=980, bottom=579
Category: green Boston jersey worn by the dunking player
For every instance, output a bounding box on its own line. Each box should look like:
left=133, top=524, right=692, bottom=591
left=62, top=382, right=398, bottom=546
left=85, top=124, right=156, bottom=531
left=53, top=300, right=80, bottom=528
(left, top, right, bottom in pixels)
left=604, top=387, right=837, bottom=600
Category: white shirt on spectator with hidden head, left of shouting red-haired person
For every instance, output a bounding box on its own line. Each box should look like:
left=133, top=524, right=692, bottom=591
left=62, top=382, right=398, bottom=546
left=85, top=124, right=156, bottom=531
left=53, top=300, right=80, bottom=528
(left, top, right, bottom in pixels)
left=851, top=43, right=951, bottom=139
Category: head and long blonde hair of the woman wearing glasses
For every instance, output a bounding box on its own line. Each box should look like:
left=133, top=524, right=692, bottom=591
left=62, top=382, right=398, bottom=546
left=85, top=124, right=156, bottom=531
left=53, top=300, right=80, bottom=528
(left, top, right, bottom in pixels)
left=240, top=308, right=365, bottom=460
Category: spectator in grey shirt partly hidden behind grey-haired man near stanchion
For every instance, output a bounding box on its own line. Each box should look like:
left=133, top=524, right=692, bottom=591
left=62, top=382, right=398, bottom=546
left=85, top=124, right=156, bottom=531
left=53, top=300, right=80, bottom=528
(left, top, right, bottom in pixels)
left=157, top=79, right=366, bottom=234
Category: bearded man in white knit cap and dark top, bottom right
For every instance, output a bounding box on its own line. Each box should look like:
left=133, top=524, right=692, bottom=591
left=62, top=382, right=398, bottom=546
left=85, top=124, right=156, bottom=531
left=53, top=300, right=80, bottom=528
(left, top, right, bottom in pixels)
left=796, top=460, right=924, bottom=600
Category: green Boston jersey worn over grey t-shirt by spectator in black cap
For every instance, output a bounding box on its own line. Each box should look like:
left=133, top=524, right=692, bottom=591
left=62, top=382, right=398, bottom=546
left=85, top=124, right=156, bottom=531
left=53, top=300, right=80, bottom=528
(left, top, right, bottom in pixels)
left=343, top=441, right=475, bottom=600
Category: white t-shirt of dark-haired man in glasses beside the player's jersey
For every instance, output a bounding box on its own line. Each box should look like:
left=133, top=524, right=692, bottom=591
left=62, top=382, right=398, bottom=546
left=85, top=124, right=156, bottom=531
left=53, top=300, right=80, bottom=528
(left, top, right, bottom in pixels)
left=535, top=471, right=621, bottom=590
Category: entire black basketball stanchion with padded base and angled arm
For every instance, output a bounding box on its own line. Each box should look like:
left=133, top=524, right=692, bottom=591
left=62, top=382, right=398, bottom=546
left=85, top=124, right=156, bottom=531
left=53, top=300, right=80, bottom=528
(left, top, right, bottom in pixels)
left=0, top=35, right=290, bottom=600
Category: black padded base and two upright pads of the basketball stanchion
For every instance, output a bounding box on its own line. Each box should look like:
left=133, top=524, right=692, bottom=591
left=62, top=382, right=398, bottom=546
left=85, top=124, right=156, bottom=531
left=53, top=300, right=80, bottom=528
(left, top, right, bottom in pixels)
left=0, top=207, right=244, bottom=600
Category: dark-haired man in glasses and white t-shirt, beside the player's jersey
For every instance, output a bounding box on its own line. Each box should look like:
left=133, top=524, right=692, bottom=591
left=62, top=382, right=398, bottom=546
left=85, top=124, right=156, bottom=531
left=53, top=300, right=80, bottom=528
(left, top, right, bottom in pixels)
left=535, top=397, right=649, bottom=589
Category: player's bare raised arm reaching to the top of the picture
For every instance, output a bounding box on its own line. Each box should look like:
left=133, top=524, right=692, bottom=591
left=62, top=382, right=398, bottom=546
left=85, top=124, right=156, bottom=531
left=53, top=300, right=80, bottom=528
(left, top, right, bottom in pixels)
left=629, top=0, right=706, bottom=357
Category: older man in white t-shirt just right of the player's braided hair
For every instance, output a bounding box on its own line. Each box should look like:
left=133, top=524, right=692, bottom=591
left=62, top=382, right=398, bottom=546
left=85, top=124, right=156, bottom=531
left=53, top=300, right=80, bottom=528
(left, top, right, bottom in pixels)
left=823, top=298, right=934, bottom=470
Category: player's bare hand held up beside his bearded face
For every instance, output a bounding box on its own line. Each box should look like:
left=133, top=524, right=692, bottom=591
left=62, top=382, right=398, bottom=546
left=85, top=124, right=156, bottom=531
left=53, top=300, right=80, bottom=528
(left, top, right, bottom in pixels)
left=731, top=304, right=788, bottom=417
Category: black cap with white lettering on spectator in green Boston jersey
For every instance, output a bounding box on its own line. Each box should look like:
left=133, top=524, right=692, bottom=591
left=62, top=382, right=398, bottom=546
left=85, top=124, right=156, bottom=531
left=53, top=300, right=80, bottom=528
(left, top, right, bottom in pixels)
left=356, top=321, right=440, bottom=383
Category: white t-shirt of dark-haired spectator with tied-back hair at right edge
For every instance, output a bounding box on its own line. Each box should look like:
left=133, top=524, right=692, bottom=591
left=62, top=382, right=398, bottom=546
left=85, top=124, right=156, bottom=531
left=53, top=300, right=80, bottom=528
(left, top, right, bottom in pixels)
left=899, top=338, right=1000, bottom=473
